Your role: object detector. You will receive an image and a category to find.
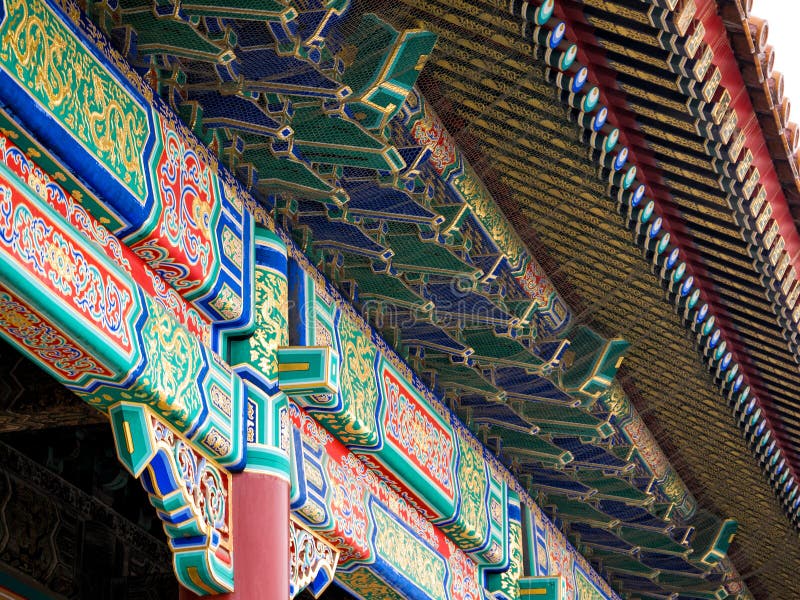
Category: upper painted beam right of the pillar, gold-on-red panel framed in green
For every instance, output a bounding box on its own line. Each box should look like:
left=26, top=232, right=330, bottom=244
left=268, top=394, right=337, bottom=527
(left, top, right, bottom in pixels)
left=289, top=239, right=508, bottom=568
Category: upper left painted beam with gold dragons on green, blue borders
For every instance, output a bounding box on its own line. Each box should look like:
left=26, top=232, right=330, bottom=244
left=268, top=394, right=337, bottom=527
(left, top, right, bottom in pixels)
left=0, top=0, right=252, bottom=338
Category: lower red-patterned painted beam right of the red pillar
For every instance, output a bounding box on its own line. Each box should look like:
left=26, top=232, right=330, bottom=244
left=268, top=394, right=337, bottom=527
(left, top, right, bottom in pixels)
left=290, top=403, right=484, bottom=600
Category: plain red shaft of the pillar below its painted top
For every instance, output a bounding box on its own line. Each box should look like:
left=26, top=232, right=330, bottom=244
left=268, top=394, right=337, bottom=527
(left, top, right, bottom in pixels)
left=179, top=472, right=289, bottom=600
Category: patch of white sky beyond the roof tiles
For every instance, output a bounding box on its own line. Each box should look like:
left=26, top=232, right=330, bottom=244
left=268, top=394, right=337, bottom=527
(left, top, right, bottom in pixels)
left=751, top=0, right=800, bottom=123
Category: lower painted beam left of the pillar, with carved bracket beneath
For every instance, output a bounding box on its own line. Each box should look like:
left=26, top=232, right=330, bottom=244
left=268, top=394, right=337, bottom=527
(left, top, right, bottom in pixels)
left=0, top=139, right=244, bottom=593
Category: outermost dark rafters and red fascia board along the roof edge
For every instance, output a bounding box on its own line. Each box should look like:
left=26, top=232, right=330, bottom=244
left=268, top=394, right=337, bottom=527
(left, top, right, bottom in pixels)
left=552, top=2, right=798, bottom=496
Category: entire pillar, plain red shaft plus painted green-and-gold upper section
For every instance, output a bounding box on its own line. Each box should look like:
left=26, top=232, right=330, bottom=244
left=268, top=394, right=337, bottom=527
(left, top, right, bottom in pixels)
left=180, top=229, right=290, bottom=600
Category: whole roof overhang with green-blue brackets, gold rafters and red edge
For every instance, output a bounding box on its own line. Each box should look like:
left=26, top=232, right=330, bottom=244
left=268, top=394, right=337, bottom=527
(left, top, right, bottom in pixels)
left=1, top=0, right=800, bottom=598
